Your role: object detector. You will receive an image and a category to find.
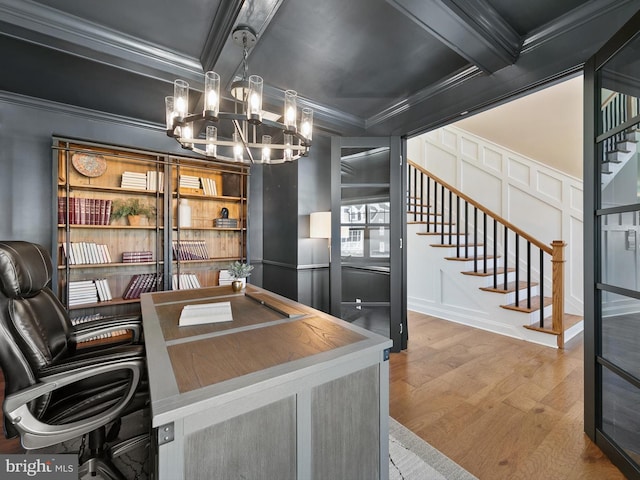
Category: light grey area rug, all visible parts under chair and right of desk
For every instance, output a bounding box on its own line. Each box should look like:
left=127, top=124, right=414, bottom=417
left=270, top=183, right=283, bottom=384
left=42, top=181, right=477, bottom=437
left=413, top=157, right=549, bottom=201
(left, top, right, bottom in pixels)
left=33, top=416, right=478, bottom=480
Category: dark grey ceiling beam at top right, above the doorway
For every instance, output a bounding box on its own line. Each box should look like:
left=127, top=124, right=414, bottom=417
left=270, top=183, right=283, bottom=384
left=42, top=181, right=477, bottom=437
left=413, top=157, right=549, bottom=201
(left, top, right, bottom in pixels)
left=387, top=0, right=522, bottom=74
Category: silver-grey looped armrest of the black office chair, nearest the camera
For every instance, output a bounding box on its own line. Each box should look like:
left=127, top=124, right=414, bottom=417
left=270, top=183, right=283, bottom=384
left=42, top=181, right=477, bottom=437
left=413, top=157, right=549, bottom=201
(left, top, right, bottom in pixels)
left=3, top=359, right=144, bottom=450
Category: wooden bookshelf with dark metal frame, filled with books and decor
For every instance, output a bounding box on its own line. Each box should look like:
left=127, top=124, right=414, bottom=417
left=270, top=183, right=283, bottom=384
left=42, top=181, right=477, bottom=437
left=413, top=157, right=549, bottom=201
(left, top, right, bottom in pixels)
left=52, top=138, right=249, bottom=317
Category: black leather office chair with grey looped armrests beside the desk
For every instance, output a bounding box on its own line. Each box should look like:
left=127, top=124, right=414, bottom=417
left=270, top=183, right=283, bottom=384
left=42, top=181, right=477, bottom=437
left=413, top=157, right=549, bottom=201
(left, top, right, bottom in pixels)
left=0, top=241, right=148, bottom=480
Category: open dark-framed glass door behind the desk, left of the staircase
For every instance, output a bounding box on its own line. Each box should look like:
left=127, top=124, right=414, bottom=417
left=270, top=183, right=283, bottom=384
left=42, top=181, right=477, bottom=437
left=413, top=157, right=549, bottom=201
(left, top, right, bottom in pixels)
left=331, top=137, right=407, bottom=351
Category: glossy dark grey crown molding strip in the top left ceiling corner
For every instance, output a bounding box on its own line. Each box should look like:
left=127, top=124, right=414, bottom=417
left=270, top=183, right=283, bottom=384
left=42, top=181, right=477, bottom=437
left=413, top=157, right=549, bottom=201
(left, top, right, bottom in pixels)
left=0, top=0, right=203, bottom=81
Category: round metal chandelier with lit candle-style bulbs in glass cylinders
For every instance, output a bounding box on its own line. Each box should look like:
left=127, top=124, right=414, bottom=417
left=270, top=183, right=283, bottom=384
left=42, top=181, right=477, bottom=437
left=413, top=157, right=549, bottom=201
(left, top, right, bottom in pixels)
left=165, top=25, right=313, bottom=164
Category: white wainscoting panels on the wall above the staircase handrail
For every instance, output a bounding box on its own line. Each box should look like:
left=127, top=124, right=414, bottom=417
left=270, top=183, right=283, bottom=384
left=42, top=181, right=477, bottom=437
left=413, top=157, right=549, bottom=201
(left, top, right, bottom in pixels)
left=416, top=126, right=583, bottom=315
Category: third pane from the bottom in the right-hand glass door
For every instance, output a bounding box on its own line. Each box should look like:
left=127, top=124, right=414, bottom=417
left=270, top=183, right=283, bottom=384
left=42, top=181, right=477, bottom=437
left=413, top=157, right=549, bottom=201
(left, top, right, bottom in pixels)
left=600, top=212, right=640, bottom=291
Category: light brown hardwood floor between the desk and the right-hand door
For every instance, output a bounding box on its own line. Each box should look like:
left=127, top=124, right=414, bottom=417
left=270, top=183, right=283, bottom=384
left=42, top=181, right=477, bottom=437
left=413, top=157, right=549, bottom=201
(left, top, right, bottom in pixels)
left=390, top=312, right=625, bottom=480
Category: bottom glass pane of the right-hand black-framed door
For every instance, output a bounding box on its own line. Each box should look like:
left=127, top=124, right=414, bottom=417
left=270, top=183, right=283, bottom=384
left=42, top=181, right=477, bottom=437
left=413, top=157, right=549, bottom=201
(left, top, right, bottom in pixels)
left=601, top=367, right=640, bottom=458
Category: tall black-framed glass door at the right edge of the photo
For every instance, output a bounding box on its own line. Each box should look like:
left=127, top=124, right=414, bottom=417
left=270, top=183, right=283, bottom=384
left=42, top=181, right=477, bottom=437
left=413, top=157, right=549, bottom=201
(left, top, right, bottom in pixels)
left=584, top=9, right=640, bottom=478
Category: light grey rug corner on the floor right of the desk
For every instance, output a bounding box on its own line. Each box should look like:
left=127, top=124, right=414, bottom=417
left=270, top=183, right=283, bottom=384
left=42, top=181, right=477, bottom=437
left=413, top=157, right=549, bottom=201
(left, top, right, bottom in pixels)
left=389, top=417, right=478, bottom=480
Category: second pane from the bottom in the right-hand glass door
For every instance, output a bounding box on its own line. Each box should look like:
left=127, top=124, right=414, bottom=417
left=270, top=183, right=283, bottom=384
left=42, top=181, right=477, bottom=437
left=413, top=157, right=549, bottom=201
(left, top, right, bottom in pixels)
left=602, top=292, right=640, bottom=378
